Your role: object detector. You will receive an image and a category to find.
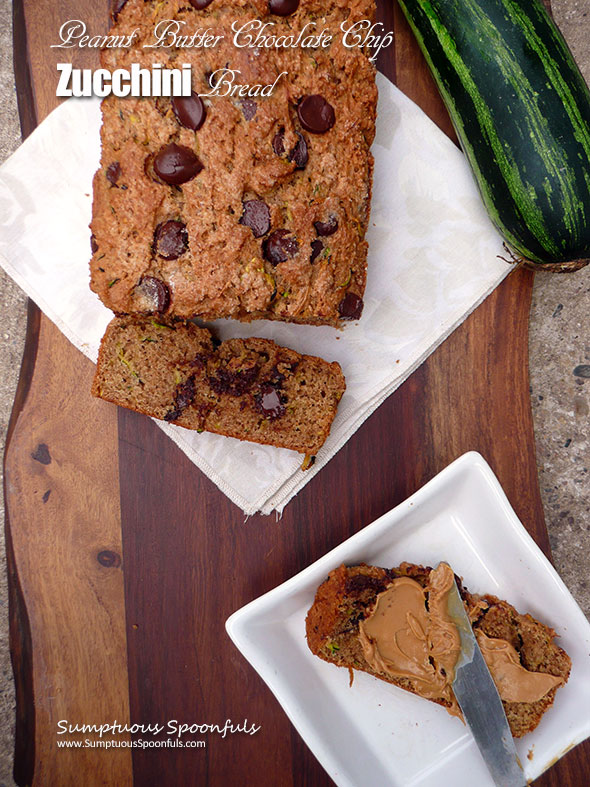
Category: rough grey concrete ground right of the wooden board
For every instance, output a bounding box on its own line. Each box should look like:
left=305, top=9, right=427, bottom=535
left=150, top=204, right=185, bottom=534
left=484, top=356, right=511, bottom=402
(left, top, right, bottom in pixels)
left=529, top=0, right=590, bottom=615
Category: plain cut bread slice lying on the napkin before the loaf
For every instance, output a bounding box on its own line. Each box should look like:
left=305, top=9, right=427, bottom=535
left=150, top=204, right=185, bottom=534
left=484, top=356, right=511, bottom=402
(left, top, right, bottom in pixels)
left=92, top=316, right=346, bottom=456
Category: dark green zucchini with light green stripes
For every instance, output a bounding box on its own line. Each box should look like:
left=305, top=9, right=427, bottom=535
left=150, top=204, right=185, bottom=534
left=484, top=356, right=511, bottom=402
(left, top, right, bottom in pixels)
left=398, top=0, right=590, bottom=264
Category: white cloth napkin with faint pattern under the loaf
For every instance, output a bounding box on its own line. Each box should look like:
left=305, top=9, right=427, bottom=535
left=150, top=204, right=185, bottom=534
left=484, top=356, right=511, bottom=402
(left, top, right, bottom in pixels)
left=0, top=75, right=509, bottom=514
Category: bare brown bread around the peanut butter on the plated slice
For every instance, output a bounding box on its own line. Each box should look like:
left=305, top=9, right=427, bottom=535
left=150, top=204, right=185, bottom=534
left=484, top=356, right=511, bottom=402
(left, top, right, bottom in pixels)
left=306, top=563, right=571, bottom=738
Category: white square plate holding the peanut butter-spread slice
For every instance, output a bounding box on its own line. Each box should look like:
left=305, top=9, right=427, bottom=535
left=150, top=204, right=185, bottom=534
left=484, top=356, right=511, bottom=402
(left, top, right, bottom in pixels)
left=226, top=452, right=590, bottom=787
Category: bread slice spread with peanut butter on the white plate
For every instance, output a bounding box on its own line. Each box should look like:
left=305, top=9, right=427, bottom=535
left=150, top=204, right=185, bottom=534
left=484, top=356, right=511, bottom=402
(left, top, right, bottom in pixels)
left=306, top=563, right=571, bottom=738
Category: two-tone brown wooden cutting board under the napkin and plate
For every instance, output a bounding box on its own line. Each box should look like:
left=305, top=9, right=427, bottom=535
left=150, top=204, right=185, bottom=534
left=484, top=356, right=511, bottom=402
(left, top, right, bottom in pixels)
left=5, top=0, right=590, bottom=787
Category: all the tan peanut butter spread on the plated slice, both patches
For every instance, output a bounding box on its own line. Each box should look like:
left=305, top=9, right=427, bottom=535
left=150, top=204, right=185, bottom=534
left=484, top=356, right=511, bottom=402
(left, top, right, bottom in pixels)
left=359, top=563, right=564, bottom=718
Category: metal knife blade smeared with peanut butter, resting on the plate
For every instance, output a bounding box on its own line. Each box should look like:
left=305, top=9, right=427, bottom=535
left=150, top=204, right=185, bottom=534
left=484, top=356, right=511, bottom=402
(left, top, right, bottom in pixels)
left=447, top=580, right=527, bottom=787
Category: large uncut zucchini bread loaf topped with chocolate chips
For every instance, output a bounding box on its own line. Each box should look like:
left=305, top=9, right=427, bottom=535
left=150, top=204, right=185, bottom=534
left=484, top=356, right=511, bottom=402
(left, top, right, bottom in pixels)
left=90, top=0, right=377, bottom=325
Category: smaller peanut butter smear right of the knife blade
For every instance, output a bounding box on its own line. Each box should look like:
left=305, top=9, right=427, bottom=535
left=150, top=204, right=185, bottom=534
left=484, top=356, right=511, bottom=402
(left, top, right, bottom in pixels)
left=475, top=631, right=564, bottom=702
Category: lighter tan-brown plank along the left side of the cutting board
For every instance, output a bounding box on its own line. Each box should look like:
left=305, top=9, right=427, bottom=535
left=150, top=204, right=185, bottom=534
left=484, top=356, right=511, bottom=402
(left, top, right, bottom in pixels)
left=4, top=0, right=132, bottom=787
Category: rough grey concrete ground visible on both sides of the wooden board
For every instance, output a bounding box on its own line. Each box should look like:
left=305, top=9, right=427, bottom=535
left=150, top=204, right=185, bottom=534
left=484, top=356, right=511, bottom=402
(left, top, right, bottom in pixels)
left=0, top=0, right=590, bottom=787
